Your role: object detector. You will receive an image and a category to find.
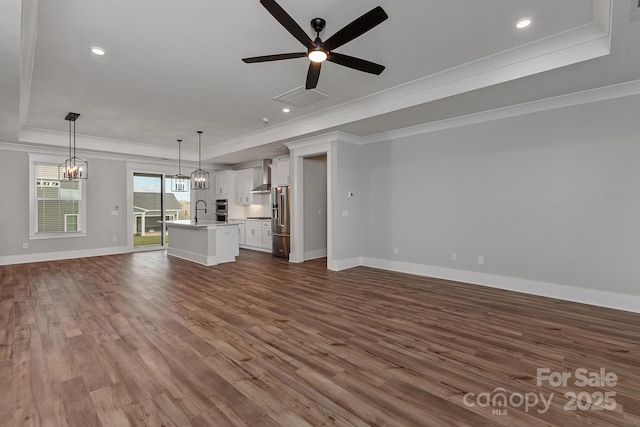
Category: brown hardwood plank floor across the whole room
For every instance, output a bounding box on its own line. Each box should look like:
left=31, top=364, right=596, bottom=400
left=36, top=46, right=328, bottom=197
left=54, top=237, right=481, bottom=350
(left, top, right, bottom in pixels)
left=0, top=250, right=640, bottom=427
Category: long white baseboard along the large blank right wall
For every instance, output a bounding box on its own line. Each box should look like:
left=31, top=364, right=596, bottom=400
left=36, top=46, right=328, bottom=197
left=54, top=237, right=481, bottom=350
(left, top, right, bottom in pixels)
left=354, top=258, right=640, bottom=313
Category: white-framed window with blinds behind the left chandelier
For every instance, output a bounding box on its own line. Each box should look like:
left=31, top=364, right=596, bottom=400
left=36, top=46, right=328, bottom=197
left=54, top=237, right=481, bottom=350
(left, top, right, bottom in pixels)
left=29, top=154, right=86, bottom=239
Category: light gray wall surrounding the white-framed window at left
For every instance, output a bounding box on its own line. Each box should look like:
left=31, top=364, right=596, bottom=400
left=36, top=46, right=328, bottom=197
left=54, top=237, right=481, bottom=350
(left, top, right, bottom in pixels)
left=0, top=150, right=127, bottom=256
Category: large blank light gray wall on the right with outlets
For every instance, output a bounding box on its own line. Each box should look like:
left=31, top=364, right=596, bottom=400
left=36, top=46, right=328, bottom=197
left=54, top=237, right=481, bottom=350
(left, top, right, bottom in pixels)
left=362, top=93, right=640, bottom=295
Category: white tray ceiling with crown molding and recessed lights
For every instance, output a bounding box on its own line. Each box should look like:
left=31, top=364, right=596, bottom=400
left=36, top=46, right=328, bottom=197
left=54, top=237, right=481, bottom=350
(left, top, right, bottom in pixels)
left=0, top=0, right=640, bottom=164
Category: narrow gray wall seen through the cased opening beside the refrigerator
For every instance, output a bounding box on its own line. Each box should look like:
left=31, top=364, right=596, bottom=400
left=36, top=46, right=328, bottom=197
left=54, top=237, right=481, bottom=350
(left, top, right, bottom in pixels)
left=303, top=154, right=327, bottom=260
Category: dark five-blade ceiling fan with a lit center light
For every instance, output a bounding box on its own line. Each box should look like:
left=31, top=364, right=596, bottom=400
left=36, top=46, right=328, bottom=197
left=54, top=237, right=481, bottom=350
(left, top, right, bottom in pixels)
left=242, top=0, right=388, bottom=89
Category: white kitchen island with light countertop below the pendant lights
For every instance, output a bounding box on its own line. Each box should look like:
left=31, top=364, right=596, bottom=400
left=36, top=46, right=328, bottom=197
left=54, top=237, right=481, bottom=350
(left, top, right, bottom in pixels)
left=164, top=220, right=240, bottom=266
